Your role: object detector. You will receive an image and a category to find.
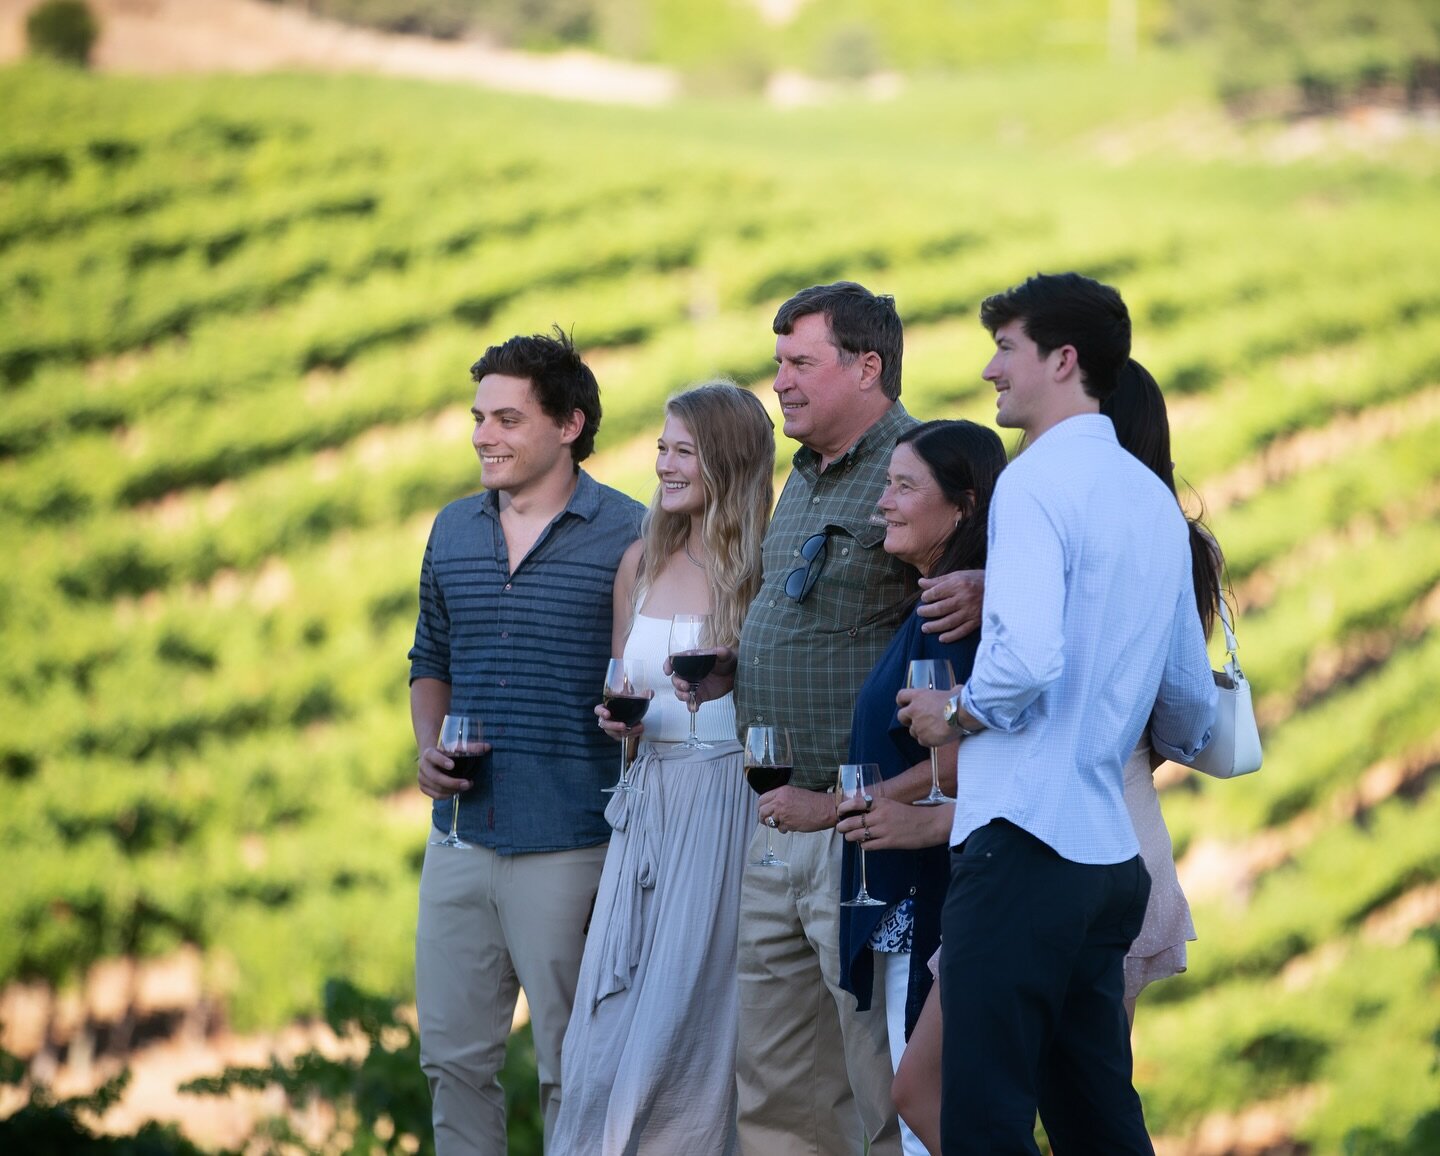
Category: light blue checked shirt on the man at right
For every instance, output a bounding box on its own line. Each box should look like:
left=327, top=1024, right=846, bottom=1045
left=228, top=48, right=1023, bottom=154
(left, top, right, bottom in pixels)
left=950, top=415, right=1215, bottom=864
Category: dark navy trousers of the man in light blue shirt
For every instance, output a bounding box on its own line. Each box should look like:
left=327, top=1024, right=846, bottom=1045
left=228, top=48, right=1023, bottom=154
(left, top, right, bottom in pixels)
left=940, top=819, right=1153, bottom=1156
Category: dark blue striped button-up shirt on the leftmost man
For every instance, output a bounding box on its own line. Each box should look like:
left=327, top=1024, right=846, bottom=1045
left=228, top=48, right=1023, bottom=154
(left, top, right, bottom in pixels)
left=410, top=471, right=645, bottom=855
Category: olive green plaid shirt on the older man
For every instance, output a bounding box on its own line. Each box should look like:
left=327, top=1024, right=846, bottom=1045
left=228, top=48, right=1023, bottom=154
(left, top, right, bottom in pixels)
left=734, top=402, right=916, bottom=790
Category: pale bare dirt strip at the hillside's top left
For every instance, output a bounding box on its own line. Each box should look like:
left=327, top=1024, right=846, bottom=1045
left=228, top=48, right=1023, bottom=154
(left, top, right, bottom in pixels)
left=0, top=0, right=680, bottom=105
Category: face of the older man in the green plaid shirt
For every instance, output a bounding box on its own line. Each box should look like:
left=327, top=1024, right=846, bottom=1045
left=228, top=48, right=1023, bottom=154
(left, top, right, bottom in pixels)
left=775, top=312, right=890, bottom=461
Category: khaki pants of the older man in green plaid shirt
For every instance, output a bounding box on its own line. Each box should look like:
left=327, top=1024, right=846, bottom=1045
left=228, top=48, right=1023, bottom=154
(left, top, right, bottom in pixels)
left=736, top=828, right=900, bottom=1156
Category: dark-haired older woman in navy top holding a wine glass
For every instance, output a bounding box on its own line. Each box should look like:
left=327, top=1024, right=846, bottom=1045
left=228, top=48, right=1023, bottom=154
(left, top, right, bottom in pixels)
left=840, top=422, right=1005, bottom=1156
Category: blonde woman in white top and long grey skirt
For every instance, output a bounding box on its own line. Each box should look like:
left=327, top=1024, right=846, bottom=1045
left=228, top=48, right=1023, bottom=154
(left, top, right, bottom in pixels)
left=547, top=381, right=775, bottom=1156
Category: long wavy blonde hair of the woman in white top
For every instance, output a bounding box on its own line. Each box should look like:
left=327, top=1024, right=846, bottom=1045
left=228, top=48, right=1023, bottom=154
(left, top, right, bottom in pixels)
left=635, top=380, right=775, bottom=646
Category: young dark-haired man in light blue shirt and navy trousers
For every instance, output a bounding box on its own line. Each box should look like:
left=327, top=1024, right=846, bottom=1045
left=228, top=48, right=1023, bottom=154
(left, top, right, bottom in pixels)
left=900, top=274, right=1215, bottom=1156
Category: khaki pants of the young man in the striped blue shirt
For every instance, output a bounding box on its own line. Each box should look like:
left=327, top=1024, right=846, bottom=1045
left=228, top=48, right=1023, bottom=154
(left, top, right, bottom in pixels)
left=415, top=844, right=605, bottom=1156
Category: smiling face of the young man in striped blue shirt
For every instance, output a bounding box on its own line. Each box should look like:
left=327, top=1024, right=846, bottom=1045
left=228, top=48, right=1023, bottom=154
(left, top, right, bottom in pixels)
left=469, top=373, right=585, bottom=497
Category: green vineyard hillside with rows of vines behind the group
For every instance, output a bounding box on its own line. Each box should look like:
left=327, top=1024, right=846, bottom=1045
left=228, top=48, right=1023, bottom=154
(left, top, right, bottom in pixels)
left=0, top=60, right=1440, bottom=1153
